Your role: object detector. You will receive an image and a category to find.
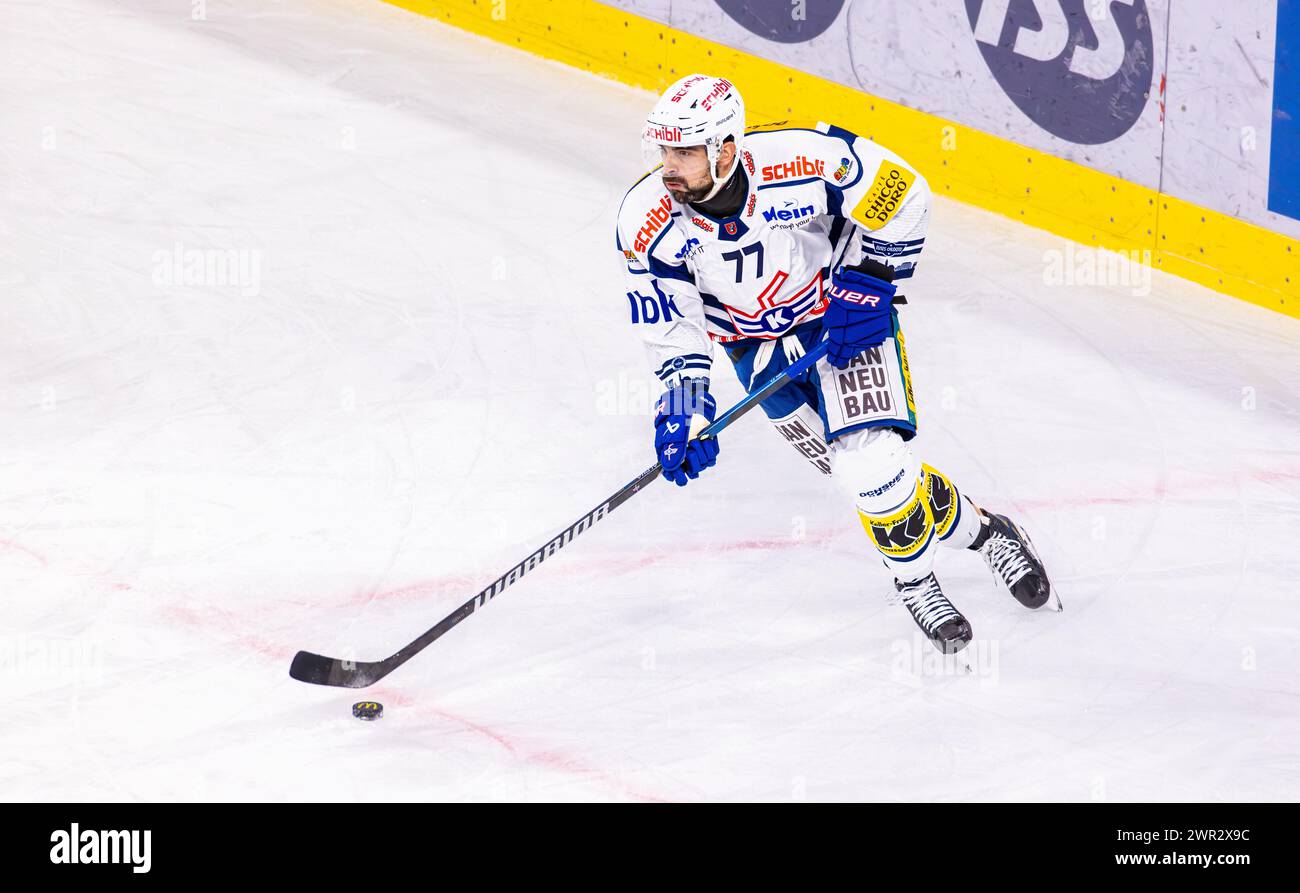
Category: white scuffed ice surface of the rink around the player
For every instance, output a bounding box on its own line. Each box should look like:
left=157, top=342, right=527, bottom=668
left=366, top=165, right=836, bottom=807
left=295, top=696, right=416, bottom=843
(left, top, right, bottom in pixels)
left=0, top=0, right=1300, bottom=801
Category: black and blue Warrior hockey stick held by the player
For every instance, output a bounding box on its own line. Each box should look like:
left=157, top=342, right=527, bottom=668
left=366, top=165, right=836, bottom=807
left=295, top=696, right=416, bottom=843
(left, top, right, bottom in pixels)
left=289, top=342, right=828, bottom=689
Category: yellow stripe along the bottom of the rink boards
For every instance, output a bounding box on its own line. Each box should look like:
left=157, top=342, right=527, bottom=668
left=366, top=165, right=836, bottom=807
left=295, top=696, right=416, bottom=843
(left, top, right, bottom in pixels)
left=386, top=0, right=1300, bottom=317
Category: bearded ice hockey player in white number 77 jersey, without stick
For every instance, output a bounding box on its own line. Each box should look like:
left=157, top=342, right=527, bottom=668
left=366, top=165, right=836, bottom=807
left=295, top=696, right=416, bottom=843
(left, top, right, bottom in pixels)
left=616, top=74, right=1050, bottom=653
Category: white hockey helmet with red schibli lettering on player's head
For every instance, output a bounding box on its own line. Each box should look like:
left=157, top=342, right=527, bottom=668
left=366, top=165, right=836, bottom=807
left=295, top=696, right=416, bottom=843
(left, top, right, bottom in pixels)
left=641, top=74, right=745, bottom=201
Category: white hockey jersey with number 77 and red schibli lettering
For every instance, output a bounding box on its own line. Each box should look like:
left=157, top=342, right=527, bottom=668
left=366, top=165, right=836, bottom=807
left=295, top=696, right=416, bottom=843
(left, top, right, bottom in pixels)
left=616, top=122, right=930, bottom=387
